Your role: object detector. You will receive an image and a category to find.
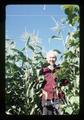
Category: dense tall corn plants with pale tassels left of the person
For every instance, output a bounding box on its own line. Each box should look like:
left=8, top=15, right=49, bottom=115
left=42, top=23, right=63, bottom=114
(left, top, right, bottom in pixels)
left=5, top=34, right=46, bottom=115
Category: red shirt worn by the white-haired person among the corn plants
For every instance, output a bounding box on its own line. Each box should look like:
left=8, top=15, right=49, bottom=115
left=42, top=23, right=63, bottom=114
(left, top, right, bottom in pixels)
left=42, top=67, right=58, bottom=99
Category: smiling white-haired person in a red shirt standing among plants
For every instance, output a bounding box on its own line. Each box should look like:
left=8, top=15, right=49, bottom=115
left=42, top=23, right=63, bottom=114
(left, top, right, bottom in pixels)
left=40, top=51, right=62, bottom=115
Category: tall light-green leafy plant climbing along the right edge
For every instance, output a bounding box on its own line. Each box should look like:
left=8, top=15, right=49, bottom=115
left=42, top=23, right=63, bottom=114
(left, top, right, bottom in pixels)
left=54, top=5, right=80, bottom=114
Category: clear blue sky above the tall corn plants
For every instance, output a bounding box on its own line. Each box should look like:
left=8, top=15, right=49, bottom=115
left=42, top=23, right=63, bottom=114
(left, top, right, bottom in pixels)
left=5, top=4, right=68, bottom=63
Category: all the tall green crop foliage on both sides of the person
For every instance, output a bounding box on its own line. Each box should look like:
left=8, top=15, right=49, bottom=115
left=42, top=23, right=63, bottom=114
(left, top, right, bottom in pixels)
left=5, top=5, right=80, bottom=115
